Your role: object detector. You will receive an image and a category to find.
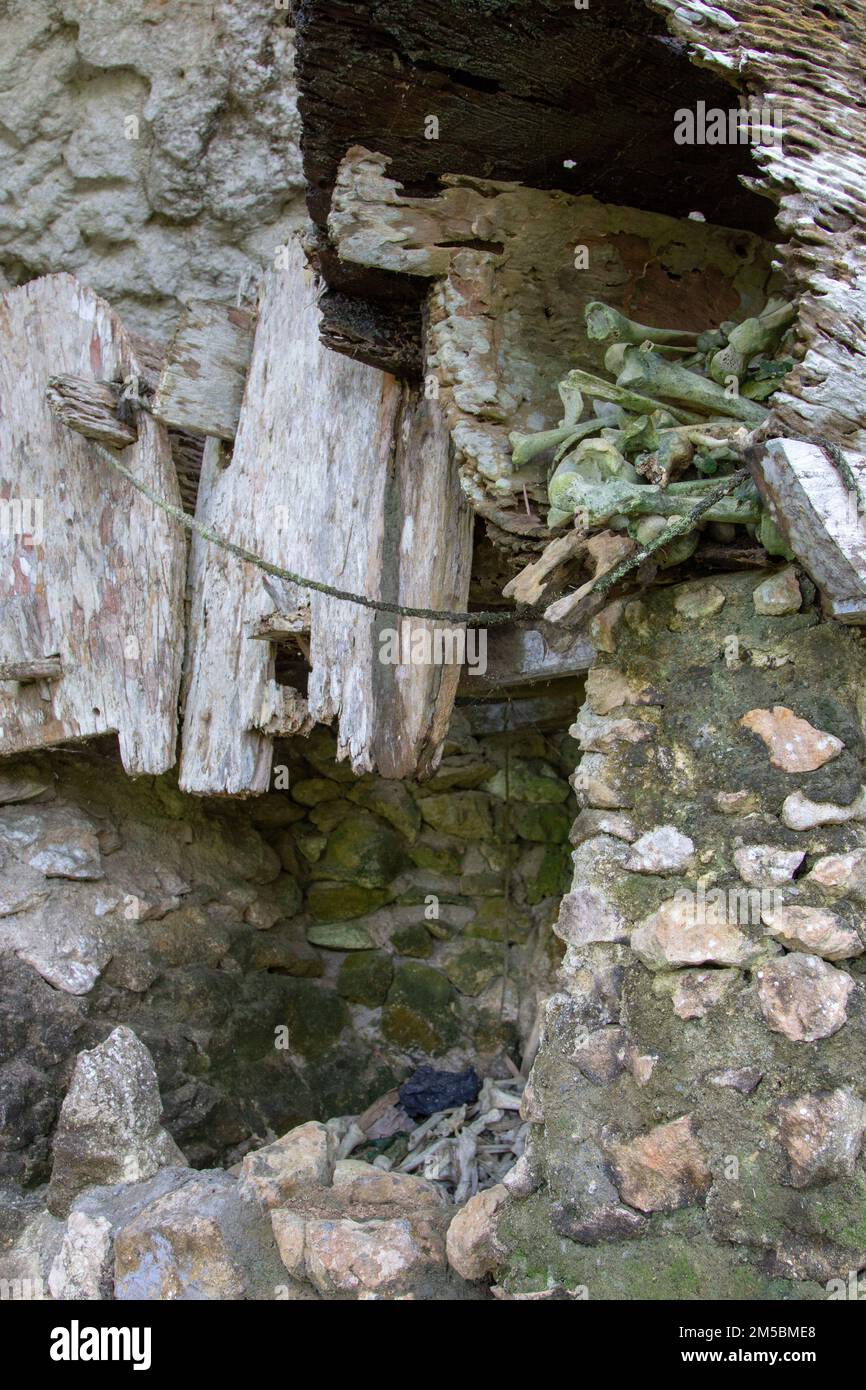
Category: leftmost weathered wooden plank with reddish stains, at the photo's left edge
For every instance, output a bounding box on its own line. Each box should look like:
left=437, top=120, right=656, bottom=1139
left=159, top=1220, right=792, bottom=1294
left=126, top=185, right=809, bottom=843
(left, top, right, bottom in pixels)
left=0, top=275, right=185, bottom=773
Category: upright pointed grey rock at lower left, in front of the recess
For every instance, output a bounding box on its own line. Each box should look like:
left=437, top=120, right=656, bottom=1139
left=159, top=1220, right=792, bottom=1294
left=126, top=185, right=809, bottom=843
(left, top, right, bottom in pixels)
left=49, top=1027, right=186, bottom=1215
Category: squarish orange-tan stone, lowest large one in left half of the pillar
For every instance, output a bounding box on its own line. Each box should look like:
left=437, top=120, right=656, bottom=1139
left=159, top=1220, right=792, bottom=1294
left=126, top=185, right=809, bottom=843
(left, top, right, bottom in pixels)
left=607, top=1115, right=712, bottom=1212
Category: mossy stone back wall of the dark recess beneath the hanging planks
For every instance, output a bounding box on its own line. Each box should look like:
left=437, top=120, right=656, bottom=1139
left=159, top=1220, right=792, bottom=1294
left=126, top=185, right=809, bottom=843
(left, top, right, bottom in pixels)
left=0, top=714, right=575, bottom=1182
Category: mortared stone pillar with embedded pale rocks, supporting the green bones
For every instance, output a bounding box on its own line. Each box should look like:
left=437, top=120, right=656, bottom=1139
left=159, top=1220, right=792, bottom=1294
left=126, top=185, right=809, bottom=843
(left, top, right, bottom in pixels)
left=499, top=570, right=866, bottom=1300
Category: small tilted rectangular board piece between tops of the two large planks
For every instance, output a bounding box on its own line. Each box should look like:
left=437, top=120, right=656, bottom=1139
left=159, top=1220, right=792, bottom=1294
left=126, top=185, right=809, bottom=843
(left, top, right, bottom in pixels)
left=152, top=300, right=256, bottom=441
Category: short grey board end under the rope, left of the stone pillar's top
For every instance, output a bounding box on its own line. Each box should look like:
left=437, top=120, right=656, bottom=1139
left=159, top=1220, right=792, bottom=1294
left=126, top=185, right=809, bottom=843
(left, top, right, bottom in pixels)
left=459, top=623, right=596, bottom=696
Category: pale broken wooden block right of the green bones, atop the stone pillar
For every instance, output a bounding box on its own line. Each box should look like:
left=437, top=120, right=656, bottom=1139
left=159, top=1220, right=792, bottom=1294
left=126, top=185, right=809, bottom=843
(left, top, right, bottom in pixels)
left=755, top=439, right=866, bottom=623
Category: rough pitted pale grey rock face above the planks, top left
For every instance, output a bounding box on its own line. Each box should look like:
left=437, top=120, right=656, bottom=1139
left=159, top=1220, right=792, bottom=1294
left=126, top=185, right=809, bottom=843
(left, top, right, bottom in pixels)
left=0, top=0, right=306, bottom=338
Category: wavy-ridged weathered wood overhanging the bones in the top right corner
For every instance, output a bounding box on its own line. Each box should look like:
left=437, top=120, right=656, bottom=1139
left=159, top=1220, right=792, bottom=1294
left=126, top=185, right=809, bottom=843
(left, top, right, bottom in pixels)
left=649, top=0, right=866, bottom=453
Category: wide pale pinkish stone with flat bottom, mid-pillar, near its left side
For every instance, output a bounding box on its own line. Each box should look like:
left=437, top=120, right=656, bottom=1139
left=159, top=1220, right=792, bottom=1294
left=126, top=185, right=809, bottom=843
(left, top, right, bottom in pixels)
left=631, top=894, right=762, bottom=970
